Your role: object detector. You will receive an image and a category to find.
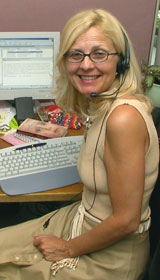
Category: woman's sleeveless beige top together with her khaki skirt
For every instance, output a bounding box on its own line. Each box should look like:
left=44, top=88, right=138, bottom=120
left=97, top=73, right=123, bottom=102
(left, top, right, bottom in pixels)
left=0, top=99, right=159, bottom=280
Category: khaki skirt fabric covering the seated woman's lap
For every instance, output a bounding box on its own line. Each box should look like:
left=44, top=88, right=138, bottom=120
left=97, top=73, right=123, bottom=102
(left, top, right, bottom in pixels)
left=0, top=203, right=149, bottom=280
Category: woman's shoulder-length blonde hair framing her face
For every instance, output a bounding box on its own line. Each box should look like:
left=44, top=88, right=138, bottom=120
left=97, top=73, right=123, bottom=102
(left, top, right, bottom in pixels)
left=55, top=9, right=151, bottom=116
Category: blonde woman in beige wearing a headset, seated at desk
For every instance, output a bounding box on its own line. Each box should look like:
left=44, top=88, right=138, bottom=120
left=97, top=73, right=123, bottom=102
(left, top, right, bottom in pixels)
left=0, top=10, right=159, bottom=280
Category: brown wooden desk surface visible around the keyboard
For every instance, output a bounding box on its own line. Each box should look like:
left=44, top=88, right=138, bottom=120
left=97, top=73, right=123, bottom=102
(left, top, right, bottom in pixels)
left=0, top=127, right=84, bottom=203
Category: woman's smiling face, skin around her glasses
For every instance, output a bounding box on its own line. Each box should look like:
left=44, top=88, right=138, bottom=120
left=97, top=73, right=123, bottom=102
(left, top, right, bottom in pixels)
left=65, top=27, right=119, bottom=96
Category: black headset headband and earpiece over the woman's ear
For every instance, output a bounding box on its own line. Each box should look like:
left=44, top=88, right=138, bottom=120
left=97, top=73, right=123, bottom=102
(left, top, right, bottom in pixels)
left=117, top=30, right=130, bottom=75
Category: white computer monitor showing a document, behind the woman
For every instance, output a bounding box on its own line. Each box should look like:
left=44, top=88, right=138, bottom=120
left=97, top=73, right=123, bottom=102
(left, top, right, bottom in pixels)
left=0, top=32, right=60, bottom=100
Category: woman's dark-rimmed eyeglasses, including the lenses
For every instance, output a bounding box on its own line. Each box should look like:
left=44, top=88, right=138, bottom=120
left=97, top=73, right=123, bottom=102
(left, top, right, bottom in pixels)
left=64, top=50, right=118, bottom=63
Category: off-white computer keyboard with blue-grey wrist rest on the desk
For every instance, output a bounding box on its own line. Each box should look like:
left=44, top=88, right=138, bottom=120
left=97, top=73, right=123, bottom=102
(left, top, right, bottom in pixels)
left=0, top=136, right=83, bottom=195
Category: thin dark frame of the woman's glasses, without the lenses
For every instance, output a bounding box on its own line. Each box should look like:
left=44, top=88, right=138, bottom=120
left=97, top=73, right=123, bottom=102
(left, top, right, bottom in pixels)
left=64, top=51, right=119, bottom=63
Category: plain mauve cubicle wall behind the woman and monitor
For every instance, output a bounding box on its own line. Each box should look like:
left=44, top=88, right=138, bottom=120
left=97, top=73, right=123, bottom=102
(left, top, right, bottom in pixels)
left=0, top=0, right=157, bottom=61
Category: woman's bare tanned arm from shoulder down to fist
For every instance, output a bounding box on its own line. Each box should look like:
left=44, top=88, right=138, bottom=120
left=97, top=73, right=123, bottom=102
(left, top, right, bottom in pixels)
left=35, top=105, right=149, bottom=261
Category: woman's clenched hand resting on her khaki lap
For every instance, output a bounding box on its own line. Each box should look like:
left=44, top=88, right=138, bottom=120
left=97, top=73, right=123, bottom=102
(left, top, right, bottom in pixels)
left=34, top=235, right=70, bottom=262
